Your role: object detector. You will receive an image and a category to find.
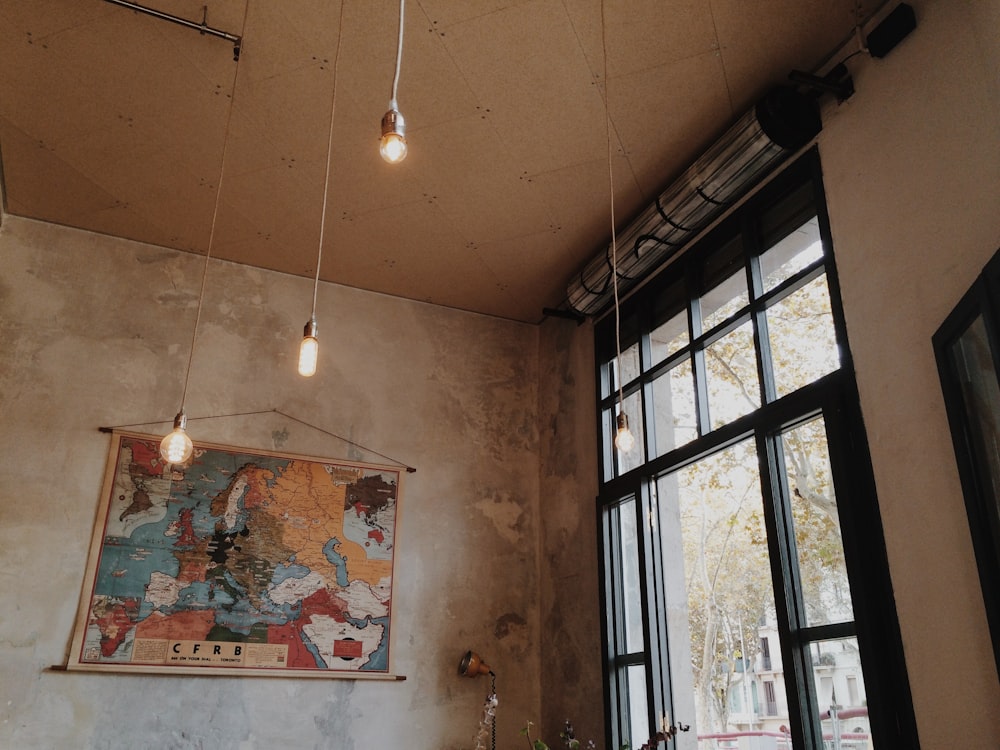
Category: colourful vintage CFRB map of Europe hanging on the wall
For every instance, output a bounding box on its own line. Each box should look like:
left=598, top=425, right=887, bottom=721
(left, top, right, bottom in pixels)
left=67, top=432, right=401, bottom=678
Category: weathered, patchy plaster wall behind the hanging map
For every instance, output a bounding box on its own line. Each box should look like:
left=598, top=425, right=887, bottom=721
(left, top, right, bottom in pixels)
left=0, top=216, right=564, bottom=750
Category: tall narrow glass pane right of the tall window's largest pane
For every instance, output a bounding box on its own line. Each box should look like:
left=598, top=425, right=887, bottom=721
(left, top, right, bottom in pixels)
left=781, top=418, right=854, bottom=626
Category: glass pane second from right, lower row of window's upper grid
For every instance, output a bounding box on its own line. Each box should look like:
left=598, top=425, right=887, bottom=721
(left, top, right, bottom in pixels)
left=705, top=321, right=760, bottom=429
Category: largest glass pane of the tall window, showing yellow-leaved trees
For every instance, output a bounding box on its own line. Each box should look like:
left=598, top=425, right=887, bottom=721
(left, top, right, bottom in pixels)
left=657, top=440, right=788, bottom=750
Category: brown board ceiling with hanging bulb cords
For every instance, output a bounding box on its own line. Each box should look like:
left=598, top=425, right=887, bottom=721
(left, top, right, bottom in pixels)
left=0, top=0, right=875, bottom=323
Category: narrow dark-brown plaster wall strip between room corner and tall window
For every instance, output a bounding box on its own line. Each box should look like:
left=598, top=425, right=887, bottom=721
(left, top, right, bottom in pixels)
left=538, top=319, right=604, bottom=747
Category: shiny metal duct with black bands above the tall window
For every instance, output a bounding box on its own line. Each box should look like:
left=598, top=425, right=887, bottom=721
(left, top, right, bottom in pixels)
left=567, top=86, right=822, bottom=315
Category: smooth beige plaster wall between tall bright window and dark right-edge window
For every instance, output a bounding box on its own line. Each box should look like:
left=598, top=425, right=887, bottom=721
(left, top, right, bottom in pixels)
left=819, top=0, right=1000, bottom=750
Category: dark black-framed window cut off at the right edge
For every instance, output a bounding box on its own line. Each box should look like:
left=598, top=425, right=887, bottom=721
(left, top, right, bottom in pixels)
left=933, top=252, right=1000, bottom=675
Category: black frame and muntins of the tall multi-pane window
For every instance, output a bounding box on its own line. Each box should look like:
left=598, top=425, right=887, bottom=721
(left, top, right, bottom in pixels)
left=595, top=147, right=919, bottom=750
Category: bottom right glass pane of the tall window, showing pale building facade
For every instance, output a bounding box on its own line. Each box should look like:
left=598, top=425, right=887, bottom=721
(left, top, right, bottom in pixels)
left=810, top=638, right=875, bottom=750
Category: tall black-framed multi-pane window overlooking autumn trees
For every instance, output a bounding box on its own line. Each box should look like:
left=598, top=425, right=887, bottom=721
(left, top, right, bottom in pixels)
left=596, top=151, right=917, bottom=750
